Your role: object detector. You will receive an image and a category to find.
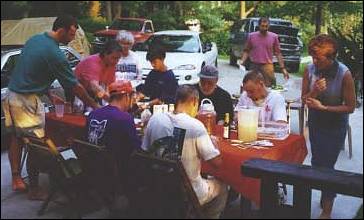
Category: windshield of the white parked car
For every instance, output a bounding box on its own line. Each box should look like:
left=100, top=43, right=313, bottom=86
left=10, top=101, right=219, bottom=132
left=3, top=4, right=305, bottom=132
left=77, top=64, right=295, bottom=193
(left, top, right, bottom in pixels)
left=135, top=35, right=200, bottom=53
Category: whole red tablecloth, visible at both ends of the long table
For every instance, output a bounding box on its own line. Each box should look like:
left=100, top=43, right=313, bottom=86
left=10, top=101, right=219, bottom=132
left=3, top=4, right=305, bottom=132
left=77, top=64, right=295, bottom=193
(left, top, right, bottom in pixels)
left=46, top=113, right=307, bottom=205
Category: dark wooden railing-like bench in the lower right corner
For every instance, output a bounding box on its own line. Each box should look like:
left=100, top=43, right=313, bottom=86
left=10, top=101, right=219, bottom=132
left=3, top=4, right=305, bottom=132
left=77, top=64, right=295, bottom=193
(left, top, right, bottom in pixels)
left=241, top=159, right=363, bottom=218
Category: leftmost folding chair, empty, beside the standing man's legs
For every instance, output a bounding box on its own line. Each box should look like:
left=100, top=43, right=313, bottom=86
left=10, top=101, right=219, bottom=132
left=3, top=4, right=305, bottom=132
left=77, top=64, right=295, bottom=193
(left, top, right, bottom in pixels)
left=26, top=138, right=82, bottom=217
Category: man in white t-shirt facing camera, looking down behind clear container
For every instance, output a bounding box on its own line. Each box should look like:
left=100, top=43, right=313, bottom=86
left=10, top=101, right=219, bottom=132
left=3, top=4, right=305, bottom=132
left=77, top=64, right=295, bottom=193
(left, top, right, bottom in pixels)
left=234, top=70, right=287, bottom=123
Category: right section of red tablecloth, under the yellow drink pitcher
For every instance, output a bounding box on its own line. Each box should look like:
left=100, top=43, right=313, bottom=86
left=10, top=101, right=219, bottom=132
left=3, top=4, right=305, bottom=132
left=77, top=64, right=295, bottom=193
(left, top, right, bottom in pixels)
left=202, top=129, right=307, bottom=205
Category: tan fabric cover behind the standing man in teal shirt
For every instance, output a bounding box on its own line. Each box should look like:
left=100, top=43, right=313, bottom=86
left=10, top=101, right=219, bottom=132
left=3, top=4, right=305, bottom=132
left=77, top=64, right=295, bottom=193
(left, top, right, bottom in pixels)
left=1, top=17, right=90, bottom=56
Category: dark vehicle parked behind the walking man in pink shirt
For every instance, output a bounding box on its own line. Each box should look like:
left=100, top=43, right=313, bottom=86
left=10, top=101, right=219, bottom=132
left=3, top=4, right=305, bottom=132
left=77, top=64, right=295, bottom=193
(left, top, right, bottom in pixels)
left=230, top=18, right=303, bottom=72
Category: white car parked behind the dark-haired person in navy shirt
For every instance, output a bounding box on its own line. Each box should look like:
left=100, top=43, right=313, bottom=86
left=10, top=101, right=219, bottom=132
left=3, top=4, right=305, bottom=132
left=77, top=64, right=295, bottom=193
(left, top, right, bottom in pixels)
left=134, top=30, right=217, bottom=85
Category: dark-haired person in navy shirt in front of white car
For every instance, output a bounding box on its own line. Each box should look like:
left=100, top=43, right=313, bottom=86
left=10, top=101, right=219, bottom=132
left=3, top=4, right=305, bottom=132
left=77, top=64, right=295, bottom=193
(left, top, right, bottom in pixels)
left=137, top=46, right=178, bottom=105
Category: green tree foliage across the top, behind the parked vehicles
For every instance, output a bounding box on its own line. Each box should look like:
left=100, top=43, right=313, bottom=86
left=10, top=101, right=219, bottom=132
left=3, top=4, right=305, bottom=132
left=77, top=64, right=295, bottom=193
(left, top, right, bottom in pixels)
left=1, top=1, right=363, bottom=60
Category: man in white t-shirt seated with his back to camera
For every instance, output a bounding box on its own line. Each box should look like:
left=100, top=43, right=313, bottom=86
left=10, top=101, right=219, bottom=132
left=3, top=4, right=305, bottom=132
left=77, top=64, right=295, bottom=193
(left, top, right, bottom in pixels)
left=142, top=85, right=227, bottom=218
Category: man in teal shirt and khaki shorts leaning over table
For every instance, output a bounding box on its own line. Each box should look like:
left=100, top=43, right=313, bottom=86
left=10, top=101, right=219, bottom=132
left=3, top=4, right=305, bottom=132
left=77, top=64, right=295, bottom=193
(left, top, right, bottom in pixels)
left=2, top=15, right=99, bottom=199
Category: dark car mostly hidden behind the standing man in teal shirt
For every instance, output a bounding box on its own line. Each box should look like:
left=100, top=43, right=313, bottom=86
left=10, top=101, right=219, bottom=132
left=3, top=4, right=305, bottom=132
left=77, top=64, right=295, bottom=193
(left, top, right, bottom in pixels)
left=1, top=46, right=81, bottom=148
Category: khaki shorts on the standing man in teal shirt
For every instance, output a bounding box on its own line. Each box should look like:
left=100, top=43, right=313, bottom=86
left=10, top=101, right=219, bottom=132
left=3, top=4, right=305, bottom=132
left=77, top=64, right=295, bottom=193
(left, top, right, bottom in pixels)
left=2, top=90, right=45, bottom=138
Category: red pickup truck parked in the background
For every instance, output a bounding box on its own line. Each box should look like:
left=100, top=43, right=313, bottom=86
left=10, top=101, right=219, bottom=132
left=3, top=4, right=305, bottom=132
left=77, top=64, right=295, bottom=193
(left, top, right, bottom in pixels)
left=92, top=18, right=154, bottom=53
